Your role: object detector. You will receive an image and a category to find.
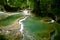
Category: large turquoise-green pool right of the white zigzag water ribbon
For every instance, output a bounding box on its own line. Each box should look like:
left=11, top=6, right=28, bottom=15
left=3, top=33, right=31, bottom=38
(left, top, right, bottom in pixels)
left=23, top=17, right=57, bottom=40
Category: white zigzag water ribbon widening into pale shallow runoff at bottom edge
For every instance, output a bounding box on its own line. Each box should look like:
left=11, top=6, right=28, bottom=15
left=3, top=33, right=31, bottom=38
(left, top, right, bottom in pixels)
left=19, top=16, right=34, bottom=40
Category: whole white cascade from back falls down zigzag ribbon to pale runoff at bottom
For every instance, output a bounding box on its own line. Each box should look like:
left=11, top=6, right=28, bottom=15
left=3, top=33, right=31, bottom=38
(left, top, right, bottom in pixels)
left=19, top=9, right=33, bottom=40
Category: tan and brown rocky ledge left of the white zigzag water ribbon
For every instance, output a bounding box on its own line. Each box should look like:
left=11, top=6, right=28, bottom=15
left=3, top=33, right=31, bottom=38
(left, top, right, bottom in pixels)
left=0, top=17, right=23, bottom=40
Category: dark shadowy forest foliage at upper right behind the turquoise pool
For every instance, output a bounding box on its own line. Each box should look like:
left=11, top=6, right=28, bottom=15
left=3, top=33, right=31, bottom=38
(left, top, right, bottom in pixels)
left=33, top=0, right=60, bottom=16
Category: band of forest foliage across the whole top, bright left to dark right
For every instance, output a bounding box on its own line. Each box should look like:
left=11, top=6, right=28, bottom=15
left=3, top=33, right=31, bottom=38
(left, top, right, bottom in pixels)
left=0, top=0, right=60, bottom=16
